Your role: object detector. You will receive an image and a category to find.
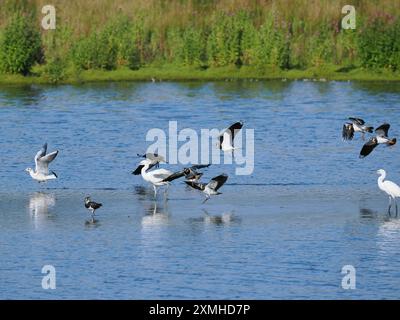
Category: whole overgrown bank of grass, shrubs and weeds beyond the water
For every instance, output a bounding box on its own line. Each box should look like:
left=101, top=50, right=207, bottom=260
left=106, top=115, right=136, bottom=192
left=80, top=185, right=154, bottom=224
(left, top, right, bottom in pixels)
left=0, top=0, right=400, bottom=83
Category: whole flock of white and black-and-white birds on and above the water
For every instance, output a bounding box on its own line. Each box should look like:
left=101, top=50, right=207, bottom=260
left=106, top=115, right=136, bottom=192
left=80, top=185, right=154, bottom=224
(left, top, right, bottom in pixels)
left=26, top=118, right=400, bottom=221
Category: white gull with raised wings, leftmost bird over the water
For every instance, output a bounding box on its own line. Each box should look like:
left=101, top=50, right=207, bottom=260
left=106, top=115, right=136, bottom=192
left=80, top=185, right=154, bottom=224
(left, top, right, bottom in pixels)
left=25, top=143, right=58, bottom=183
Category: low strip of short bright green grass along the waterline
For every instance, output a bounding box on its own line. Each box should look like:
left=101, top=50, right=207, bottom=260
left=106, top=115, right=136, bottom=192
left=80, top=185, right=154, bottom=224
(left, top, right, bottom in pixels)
left=0, top=65, right=400, bottom=85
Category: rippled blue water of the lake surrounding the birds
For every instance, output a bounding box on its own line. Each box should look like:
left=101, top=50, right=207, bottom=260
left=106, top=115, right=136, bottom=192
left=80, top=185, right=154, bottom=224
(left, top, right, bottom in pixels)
left=0, top=81, right=400, bottom=299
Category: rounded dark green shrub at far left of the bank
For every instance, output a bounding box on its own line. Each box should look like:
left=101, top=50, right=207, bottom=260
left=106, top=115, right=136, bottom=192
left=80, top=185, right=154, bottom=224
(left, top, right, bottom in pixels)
left=0, top=15, right=42, bottom=75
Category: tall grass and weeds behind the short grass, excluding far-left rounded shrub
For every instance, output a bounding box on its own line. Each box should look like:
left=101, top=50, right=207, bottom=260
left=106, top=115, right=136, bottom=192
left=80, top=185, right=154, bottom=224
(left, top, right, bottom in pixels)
left=0, top=0, right=400, bottom=76
